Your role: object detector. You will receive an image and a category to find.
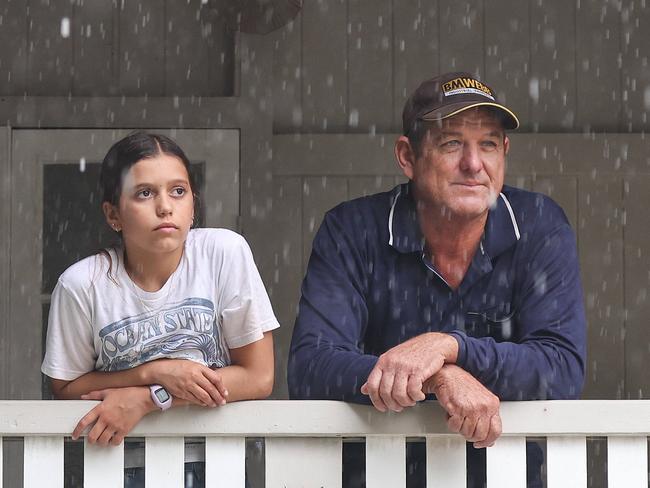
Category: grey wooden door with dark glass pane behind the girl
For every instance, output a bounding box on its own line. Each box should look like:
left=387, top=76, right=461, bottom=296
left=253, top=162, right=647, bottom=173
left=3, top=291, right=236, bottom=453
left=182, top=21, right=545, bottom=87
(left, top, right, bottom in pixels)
left=0, top=129, right=239, bottom=400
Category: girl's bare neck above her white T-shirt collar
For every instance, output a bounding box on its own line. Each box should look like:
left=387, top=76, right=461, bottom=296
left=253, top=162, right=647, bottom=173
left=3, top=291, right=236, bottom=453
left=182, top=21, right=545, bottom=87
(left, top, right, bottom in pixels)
left=124, top=247, right=183, bottom=292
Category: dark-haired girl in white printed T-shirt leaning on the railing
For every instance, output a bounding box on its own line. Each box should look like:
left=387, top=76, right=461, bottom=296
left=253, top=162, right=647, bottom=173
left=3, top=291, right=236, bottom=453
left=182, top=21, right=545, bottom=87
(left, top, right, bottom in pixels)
left=41, top=132, right=279, bottom=486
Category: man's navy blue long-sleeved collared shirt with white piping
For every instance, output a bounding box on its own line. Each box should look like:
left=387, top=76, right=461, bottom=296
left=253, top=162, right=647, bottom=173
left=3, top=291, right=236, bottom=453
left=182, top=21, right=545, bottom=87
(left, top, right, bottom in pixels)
left=288, top=183, right=585, bottom=403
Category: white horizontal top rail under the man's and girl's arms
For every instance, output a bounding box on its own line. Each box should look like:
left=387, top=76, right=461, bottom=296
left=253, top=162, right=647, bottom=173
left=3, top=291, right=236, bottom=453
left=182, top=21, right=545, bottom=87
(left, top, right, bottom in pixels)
left=0, top=400, right=650, bottom=437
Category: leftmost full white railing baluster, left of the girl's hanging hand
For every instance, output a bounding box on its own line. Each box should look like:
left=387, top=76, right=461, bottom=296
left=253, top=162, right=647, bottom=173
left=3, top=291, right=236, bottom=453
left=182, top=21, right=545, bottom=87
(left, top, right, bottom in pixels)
left=23, top=436, right=63, bottom=488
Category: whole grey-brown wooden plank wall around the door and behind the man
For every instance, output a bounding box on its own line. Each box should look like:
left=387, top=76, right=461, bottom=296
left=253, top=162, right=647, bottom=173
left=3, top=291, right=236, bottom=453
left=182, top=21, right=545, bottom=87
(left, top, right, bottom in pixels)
left=0, top=0, right=650, bottom=404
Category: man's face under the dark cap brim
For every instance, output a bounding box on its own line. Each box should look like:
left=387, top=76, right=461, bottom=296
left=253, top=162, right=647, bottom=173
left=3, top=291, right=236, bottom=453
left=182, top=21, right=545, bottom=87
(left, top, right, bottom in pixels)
left=403, top=109, right=509, bottom=219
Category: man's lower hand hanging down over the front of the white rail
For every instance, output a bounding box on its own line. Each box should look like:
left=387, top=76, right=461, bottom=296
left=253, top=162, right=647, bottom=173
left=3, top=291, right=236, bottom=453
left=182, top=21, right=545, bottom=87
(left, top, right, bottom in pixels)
left=424, top=364, right=501, bottom=448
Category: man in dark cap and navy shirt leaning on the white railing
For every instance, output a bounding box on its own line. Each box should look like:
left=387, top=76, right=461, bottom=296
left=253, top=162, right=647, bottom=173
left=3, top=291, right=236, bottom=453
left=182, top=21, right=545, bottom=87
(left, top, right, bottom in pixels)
left=288, top=73, right=585, bottom=484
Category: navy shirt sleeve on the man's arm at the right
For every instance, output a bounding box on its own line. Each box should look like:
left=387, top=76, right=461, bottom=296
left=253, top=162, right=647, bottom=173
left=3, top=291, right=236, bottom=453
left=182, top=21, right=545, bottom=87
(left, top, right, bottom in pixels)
left=452, top=224, right=586, bottom=400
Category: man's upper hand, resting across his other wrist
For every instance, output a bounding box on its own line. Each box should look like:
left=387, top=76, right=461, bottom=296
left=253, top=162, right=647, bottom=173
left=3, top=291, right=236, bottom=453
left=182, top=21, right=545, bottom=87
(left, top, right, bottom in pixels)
left=361, top=332, right=458, bottom=412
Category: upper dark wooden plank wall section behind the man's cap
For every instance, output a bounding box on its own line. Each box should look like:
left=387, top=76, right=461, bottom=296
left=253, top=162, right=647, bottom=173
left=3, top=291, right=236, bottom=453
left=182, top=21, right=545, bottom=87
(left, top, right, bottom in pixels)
left=274, top=0, right=650, bottom=133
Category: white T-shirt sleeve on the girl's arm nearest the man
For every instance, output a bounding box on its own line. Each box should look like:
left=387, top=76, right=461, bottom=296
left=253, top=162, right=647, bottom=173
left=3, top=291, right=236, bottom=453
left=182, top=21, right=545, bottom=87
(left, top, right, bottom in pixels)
left=218, top=234, right=280, bottom=349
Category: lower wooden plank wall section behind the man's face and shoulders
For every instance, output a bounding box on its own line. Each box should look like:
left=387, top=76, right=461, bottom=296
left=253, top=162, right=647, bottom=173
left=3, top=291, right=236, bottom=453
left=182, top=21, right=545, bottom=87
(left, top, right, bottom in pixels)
left=272, top=133, right=650, bottom=398
